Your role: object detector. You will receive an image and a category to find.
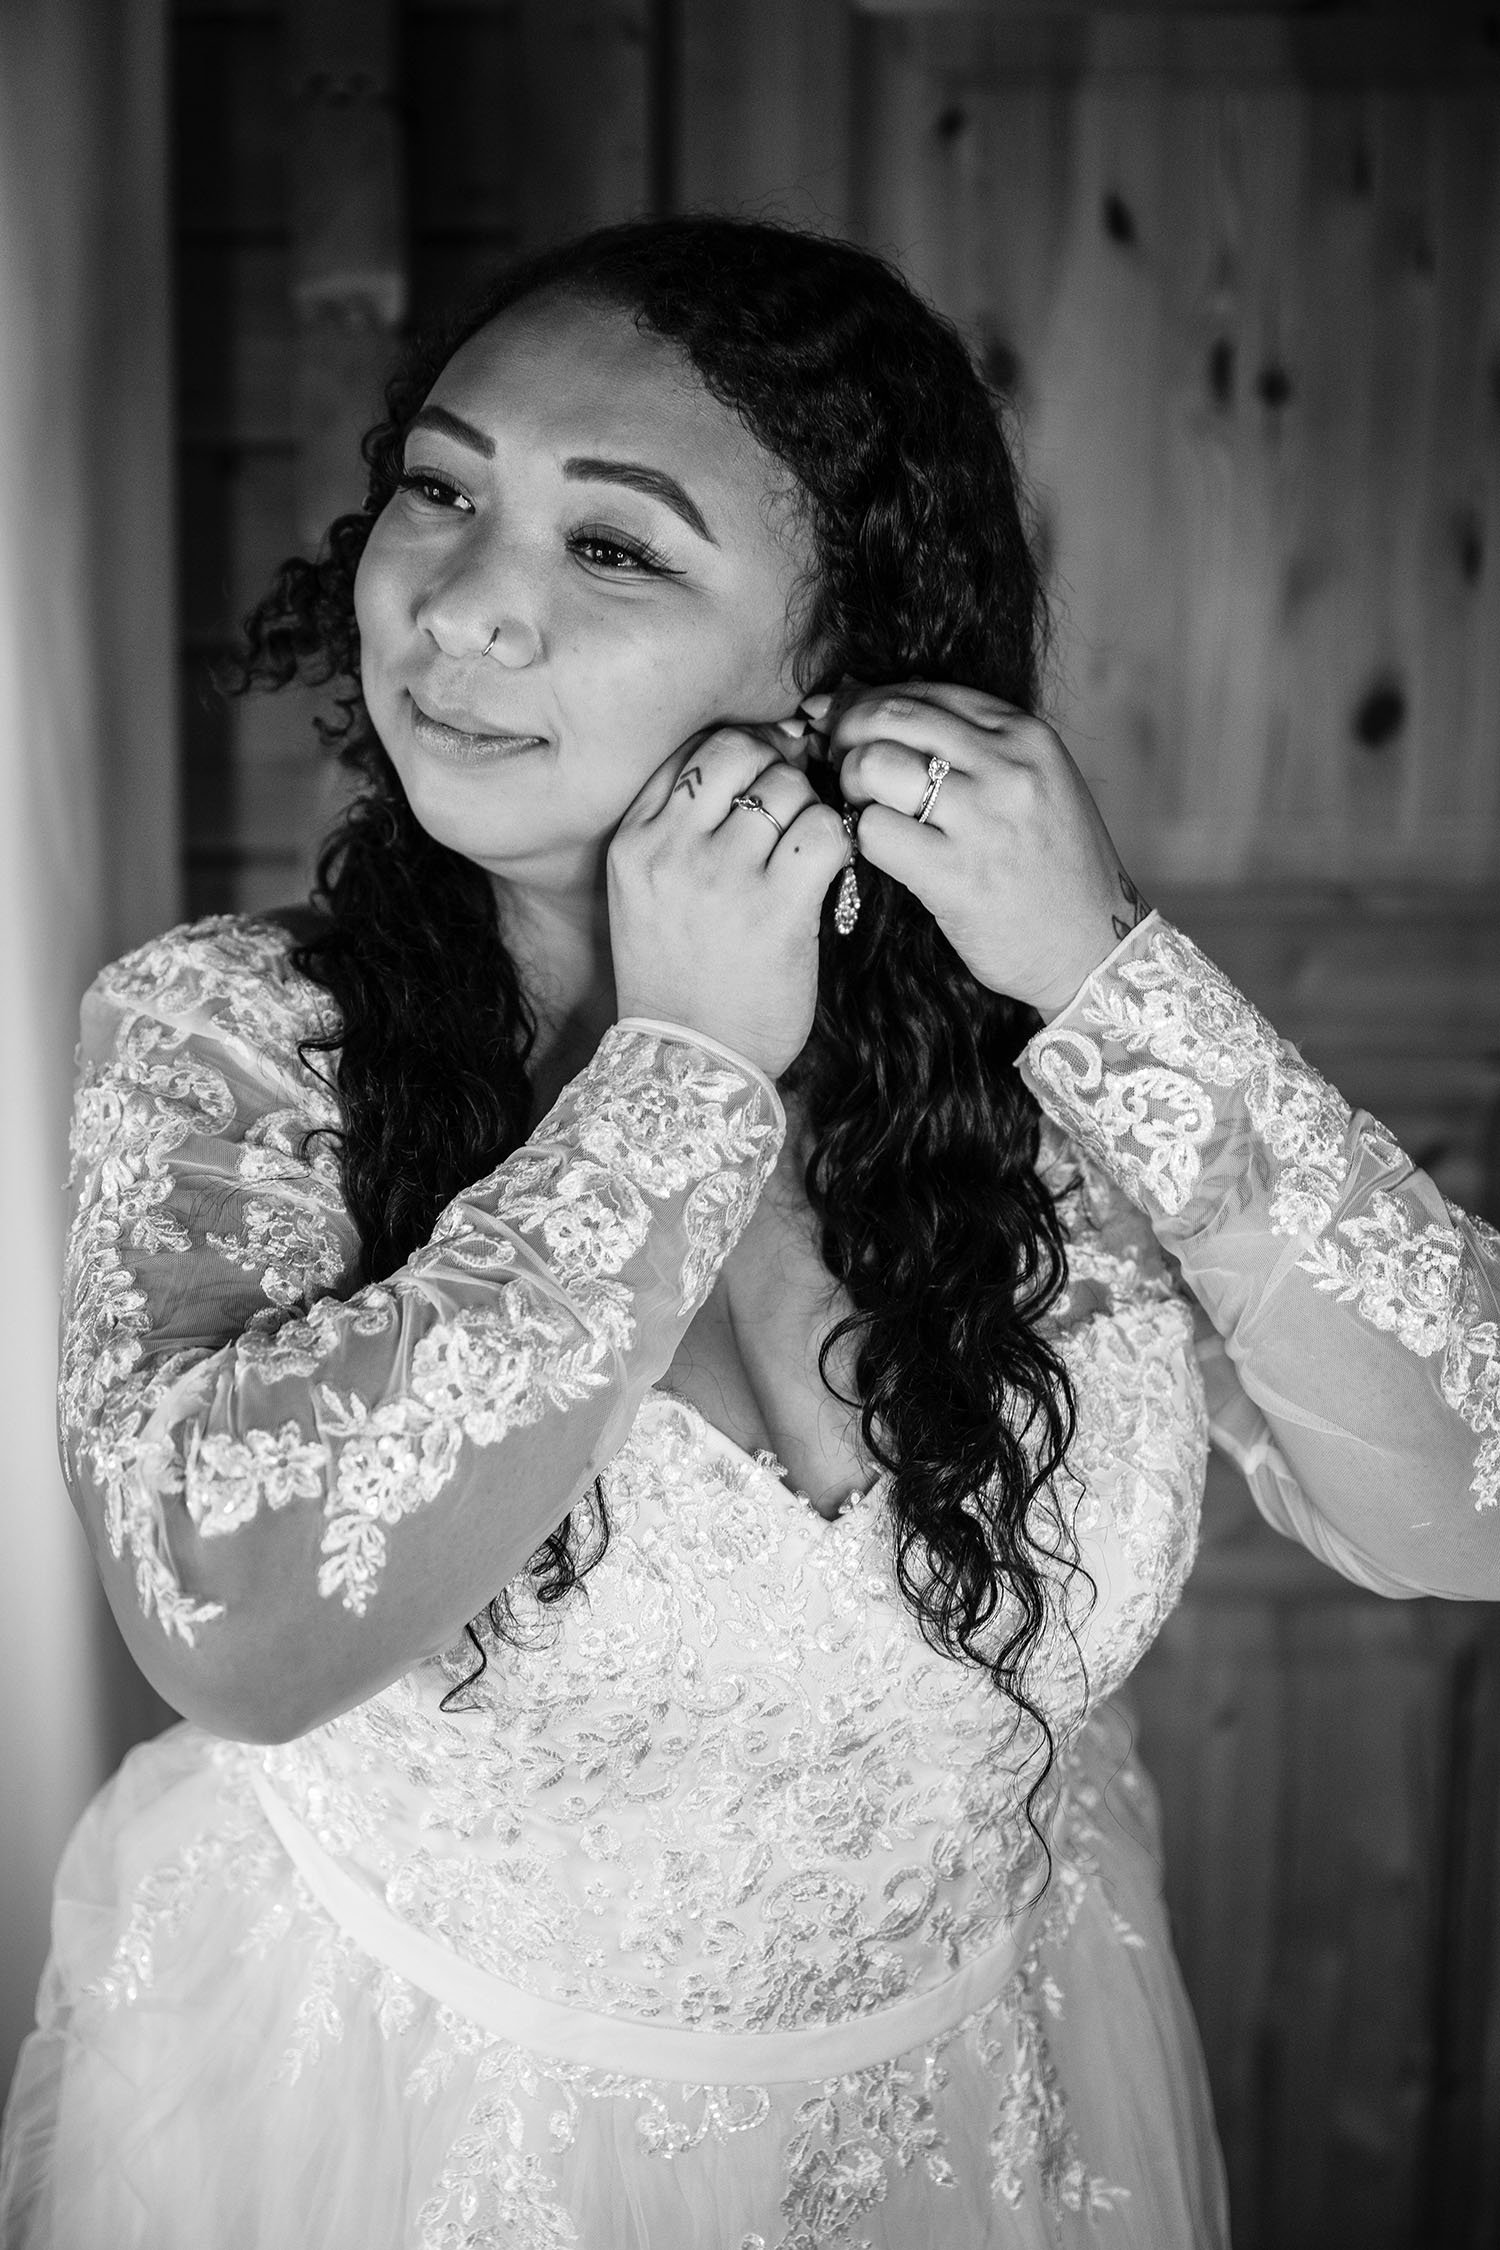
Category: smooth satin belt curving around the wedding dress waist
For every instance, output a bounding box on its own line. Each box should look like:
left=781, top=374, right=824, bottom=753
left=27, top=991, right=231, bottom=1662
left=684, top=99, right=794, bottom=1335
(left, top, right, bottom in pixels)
left=252, top=1773, right=1030, bottom=2086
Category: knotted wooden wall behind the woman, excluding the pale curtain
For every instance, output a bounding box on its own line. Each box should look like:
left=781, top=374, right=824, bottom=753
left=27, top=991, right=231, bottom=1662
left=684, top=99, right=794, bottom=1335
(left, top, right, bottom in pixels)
left=175, top=0, right=1500, bottom=2250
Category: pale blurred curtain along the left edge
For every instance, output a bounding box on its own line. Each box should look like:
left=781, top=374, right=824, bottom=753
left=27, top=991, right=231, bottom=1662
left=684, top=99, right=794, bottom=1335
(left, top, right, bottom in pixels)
left=0, top=0, right=180, bottom=2086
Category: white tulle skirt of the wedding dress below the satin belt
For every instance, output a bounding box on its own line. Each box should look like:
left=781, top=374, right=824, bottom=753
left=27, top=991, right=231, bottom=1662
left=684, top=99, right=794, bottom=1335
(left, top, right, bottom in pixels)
left=0, top=1715, right=1228, bottom=2250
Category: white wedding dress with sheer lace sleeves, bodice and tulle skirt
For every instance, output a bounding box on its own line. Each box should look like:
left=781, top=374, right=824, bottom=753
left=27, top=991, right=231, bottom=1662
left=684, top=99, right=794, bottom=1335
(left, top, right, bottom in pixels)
left=0, top=916, right=1500, bottom=2250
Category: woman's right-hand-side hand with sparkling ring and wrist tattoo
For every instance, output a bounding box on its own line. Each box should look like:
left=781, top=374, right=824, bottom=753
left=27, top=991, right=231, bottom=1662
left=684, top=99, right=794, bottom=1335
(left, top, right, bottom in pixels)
left=801, top=680, right=1151, bottom=1019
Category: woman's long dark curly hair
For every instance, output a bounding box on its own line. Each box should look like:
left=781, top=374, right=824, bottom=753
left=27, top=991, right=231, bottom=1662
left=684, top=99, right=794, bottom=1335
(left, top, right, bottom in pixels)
left=241, top=214, right=1077, bottom=1796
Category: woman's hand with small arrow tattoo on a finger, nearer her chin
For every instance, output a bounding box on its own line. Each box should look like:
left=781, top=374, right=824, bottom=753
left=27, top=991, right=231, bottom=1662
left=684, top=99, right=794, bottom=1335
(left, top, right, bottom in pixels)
left=607, top=725, right=850, bottom=1078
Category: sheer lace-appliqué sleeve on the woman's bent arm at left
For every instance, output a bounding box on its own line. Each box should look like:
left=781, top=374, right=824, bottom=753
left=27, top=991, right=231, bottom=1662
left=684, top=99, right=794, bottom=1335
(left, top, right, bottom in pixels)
left=58, top=918, right=785, bottom=1719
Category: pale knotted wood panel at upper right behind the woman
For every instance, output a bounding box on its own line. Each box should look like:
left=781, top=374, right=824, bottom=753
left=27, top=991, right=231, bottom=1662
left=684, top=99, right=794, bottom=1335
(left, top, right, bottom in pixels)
left=855, top=16, right=1500, bottom=889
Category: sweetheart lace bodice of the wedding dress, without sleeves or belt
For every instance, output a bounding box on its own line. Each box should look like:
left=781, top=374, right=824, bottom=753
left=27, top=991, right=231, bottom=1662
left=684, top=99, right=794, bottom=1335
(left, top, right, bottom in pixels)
left=263, top=1296, right=1205, bottom=2030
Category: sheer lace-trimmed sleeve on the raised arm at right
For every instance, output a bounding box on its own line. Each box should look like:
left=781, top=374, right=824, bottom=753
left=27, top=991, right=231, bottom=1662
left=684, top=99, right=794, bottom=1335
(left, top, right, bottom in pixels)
left=1021, top=914, right=1500, bottom=1600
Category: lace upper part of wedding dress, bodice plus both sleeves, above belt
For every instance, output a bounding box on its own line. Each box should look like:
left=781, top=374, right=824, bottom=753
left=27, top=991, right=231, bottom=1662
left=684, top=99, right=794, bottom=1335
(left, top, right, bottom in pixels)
left=61, top=916, right=1500, bottom=2027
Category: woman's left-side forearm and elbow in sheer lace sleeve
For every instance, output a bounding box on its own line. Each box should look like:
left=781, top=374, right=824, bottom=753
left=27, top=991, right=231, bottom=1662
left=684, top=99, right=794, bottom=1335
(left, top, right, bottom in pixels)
left=65, top=1026, right=785, bottom=1735
